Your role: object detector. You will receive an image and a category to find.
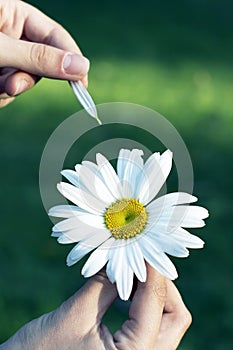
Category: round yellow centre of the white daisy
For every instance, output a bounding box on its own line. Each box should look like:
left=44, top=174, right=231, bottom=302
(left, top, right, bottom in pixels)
left=104, top=198, right=147, bottom=239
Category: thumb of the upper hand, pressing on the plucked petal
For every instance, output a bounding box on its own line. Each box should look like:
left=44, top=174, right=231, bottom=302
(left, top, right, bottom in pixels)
left=0, top=33, right=89, bottom=80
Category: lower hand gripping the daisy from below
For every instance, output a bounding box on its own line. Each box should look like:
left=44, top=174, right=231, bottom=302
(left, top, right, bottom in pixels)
left=0, top=265, right=191, bottom=350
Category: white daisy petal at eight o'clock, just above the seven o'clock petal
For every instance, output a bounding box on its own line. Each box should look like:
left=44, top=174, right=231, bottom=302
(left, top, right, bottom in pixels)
left=67, top=230, right=110, bottom=266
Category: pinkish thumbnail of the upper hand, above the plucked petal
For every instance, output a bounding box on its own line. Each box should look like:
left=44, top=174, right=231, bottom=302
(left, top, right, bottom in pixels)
left=63, top=54, right=89, bottom=76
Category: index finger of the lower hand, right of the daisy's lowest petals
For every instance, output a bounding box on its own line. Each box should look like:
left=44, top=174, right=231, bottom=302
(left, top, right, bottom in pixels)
left=114, top=264, right=166, bottom=350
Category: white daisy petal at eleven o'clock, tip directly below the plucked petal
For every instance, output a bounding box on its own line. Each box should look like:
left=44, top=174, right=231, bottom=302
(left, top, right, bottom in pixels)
left=96, top=153, right=122, bottom=199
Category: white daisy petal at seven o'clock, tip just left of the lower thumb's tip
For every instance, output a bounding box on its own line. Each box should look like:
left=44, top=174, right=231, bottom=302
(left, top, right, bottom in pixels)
left=82, top=237, right=114, bottom=277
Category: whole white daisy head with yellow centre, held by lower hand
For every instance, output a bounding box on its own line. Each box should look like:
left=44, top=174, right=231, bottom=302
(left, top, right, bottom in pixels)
left=49, top=149, right=208, bottom=300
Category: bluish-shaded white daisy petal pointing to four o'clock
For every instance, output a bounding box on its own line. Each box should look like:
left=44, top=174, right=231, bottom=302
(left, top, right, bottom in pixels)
left=147, top=233, right=189, bottom=258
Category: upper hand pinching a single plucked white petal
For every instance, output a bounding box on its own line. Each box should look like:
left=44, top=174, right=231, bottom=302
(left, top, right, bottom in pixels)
left=0, top=0, right=89, bottom=107
